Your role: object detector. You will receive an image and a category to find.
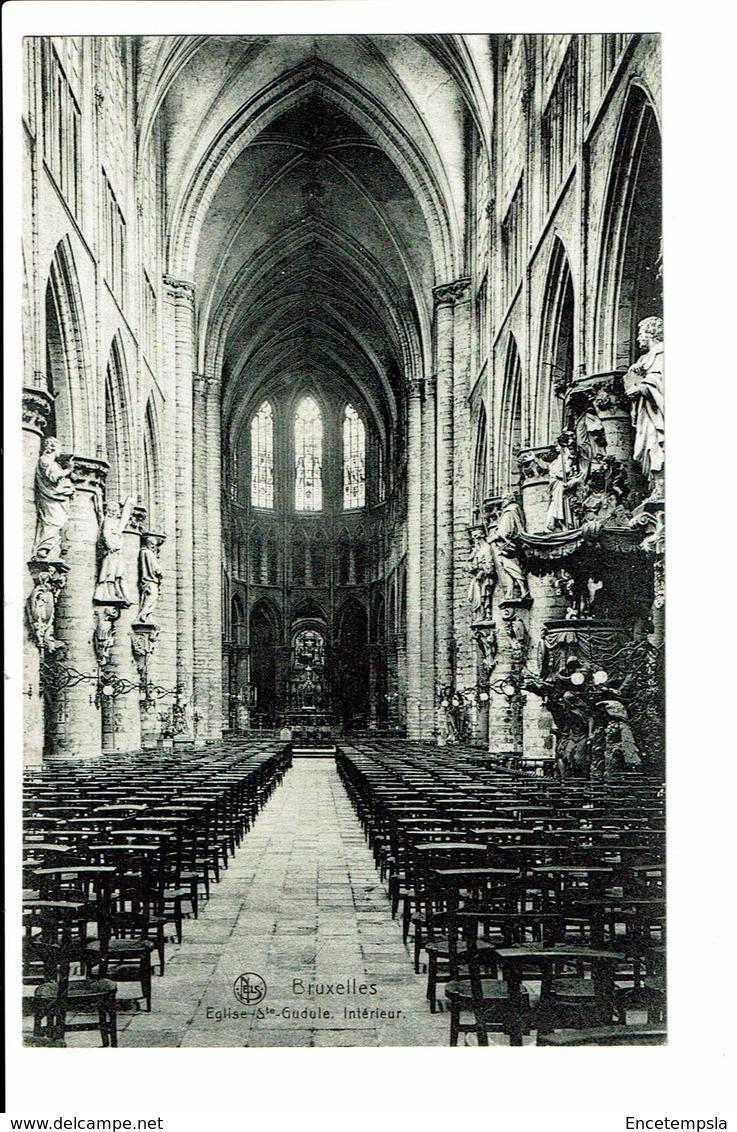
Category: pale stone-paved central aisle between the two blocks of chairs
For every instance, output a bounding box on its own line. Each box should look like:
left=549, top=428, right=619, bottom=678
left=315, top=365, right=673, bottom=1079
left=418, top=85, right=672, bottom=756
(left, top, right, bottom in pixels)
left=120, top=758, right=448, bottom=1046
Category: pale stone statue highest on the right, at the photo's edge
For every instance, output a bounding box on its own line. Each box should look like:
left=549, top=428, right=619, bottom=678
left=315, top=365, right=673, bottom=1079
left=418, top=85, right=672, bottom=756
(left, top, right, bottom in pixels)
left=624, top=317, right=666, bottom=498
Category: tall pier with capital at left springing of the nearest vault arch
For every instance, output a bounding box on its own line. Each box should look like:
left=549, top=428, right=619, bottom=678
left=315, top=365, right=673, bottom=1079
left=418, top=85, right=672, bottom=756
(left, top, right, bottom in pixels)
left=164, top=275, right=195, bottom=741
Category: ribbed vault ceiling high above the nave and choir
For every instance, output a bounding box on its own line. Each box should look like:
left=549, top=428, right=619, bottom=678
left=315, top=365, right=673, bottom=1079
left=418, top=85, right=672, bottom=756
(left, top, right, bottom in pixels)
left=139, top=36, right=495, bottom=438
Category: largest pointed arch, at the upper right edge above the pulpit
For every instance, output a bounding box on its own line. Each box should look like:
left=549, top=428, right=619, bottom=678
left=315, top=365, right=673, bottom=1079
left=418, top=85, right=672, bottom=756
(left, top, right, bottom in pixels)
left=595, top=85, right=662, bottom=370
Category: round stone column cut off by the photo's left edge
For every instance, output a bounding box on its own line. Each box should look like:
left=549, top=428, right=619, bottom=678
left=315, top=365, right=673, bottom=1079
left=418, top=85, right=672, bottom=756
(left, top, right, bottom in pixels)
left=23, top=378, right=51, bottom=766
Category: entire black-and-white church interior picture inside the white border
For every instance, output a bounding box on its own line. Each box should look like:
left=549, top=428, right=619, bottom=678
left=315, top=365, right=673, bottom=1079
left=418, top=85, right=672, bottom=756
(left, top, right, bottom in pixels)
left=22, top=34, right=666, bottom=1047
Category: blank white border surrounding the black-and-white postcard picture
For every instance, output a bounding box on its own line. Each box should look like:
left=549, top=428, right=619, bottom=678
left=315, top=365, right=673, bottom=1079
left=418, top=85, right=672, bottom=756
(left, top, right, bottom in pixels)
left=1, top=0, right=737, bottom=1132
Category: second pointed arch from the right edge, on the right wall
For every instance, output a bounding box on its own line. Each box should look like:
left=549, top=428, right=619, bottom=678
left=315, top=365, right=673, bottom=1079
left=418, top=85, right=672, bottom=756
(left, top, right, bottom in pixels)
left=537, top=235, right=575, bottom=443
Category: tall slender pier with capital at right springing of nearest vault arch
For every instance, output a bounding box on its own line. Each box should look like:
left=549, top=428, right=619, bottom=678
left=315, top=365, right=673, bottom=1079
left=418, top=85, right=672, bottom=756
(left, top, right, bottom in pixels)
left=435, top=283, right=455, bottom=687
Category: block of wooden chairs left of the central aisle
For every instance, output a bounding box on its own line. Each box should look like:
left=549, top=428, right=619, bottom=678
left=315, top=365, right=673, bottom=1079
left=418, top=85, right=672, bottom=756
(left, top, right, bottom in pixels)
left=23, top=744, right=291, bottom=1046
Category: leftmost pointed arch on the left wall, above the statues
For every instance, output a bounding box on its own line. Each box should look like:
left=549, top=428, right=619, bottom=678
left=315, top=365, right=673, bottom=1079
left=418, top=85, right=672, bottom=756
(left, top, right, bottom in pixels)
left=44, top=237, right=96, bottom=454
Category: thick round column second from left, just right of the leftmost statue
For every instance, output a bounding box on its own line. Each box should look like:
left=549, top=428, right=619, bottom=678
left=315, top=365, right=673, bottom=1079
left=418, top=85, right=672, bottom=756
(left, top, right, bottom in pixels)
left=46, top=456, right=108, bottom=758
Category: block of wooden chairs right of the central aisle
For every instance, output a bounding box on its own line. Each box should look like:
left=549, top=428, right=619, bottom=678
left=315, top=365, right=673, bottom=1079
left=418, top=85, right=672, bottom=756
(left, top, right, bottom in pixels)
left=337, top=741, right=665, bottom=1045
